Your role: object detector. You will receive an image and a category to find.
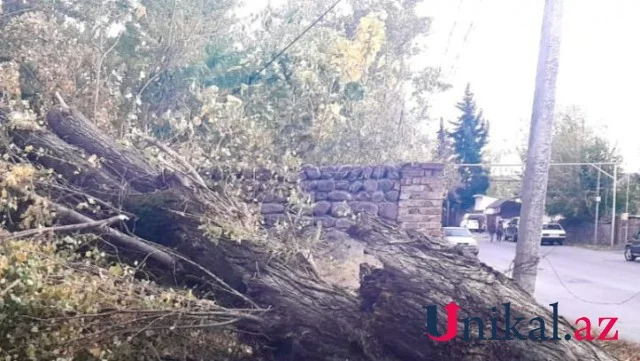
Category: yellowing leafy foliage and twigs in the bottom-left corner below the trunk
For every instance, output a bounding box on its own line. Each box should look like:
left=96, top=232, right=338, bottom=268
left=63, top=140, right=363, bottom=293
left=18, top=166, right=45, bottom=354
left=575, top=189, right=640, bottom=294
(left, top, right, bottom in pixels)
left=0, top=237, right=258, bottom=361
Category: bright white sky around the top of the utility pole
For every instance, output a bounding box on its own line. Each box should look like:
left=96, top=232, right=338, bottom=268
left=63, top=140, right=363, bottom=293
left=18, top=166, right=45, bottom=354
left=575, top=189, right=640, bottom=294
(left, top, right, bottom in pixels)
left=236, top=0, right=640, bottom=171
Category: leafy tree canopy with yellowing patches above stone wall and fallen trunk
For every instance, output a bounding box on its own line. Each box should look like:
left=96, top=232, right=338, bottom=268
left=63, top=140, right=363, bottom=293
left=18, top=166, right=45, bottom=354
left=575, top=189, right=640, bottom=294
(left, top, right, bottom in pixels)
left=0, top=0, right=445, bottom=172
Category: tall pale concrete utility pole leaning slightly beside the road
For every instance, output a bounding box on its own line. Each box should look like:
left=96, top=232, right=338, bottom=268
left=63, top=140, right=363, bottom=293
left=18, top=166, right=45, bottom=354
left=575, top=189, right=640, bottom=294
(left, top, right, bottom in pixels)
left=513, top=0, right=563, bottom=295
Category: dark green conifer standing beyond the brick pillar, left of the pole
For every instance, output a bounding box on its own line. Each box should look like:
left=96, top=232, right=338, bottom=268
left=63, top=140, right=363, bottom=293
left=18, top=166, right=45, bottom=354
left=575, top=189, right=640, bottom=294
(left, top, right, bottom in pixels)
left=449, top=85, right=489, bottom=210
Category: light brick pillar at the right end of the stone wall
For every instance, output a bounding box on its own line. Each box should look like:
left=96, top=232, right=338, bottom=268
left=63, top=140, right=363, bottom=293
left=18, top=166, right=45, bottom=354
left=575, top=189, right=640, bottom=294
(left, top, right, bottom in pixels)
left=397, top=163, right=444, bottom=237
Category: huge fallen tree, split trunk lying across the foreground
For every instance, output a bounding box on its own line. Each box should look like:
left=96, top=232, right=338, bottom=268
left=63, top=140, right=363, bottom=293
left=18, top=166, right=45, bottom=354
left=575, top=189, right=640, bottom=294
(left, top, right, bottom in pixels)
left=0, top=106, right=614, bottom=361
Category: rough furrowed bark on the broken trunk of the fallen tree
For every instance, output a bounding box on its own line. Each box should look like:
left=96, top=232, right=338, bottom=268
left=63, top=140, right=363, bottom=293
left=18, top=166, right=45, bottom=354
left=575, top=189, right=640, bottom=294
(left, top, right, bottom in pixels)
left=1, top=105, right=614, bottom=361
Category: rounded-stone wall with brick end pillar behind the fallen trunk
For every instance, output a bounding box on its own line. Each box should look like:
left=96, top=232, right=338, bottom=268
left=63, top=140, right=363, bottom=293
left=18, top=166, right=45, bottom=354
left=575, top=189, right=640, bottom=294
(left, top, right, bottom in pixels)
left=259, top=163, right=444, bottom=236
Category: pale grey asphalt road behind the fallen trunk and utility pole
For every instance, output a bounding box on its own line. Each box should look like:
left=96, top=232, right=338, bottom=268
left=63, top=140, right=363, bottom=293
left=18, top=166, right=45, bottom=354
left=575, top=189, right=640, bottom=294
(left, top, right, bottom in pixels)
left=478, top=239, right=640, bottom=342
